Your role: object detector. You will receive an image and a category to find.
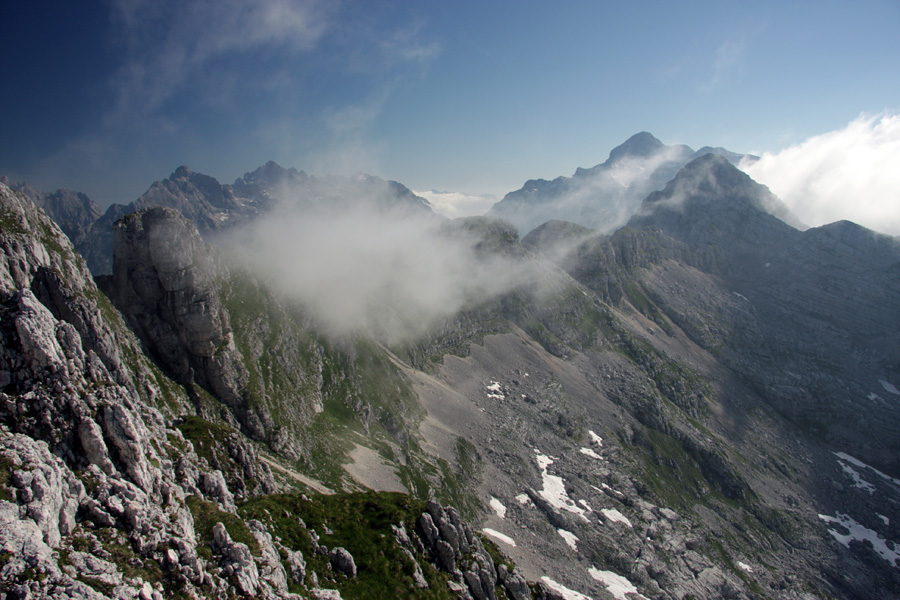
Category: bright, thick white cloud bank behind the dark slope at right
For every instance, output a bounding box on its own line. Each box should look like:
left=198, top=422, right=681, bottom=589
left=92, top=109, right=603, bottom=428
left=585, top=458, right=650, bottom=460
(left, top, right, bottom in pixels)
left=741, top=115, right=900, bottom=235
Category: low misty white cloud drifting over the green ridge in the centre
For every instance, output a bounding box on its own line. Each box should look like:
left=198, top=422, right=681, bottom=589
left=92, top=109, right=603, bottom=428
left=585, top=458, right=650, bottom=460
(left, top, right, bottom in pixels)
left=229, top=203, right=526, bottom=342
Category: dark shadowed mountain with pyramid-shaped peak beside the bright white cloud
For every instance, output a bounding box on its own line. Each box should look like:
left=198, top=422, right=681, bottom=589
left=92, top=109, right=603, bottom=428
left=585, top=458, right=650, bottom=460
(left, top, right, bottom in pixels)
left=629, top=155, right=900, bottom=471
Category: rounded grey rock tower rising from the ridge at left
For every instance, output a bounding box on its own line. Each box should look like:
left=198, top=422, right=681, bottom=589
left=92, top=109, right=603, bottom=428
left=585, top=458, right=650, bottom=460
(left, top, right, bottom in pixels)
left=106, top=208, right=250, bottom=424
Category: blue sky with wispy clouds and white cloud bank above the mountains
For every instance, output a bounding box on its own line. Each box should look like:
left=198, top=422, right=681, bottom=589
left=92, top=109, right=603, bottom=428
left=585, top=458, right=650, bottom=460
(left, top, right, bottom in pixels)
left=0, top=0, right=900, bottom=235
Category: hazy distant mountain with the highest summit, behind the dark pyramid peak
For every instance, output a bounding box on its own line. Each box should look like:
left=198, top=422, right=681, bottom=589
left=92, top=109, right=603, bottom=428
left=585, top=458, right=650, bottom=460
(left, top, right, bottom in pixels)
left=488, top=132, right=764, bottom=235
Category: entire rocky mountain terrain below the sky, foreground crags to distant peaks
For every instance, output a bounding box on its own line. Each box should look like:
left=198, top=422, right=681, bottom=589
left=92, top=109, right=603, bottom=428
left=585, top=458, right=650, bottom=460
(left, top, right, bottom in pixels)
left=0, top=133, right=900, bottom=600
